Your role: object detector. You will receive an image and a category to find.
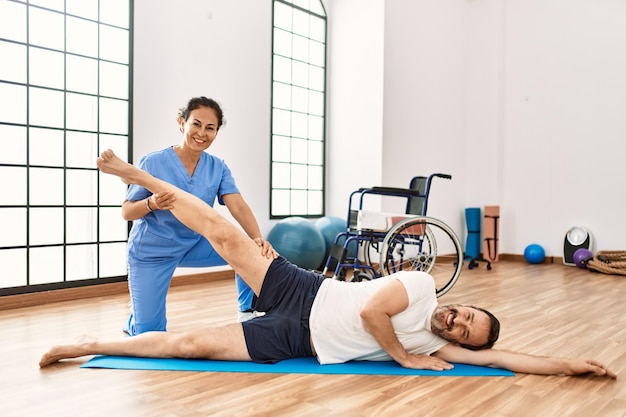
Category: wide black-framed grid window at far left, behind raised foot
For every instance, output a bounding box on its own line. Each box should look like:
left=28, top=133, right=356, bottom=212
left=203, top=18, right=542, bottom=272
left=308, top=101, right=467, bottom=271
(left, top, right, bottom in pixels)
left=0, top=0, right=132, bottom=295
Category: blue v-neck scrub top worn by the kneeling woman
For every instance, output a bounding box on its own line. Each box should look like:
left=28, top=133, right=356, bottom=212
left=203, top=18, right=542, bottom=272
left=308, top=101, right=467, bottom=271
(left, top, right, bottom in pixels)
left=126, top=147, right=239, bottom=244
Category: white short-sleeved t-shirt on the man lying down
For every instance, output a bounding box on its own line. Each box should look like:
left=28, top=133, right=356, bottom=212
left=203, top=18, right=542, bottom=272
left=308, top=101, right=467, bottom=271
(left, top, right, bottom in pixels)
left=309, top=271, right=448, bottom=364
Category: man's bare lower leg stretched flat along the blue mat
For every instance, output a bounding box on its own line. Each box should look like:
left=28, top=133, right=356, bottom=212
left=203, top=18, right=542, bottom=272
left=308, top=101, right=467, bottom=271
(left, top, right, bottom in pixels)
left=39, top=323, right=251, bottom=368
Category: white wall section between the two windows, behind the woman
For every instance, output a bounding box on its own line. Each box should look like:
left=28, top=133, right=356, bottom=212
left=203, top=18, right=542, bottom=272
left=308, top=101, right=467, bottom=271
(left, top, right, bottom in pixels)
left=133, top=0, right=272, bottom=233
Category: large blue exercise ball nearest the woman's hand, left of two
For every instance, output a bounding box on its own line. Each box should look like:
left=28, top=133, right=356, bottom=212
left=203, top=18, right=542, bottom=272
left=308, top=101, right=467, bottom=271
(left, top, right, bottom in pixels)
left=267, top=216, right=326, bottom=269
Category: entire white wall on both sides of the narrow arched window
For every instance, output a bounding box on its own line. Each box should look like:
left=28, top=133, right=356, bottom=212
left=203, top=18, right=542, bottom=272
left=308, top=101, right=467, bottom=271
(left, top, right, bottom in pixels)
left=134, top=0, right=626, bottom=256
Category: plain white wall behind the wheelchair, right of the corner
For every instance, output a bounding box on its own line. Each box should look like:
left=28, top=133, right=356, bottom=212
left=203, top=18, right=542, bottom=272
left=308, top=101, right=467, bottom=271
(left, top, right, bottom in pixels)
left=383, top=0, right=626, bottom=256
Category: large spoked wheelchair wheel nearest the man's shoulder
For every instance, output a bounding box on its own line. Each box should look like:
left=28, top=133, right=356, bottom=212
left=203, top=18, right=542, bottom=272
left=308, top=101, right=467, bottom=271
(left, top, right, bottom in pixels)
left=380, top=216, right=463, bottom=297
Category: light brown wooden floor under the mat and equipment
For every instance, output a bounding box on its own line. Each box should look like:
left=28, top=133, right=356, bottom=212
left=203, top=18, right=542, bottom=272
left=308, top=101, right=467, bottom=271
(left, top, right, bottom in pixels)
left=0, top=262, right=626, bottom=417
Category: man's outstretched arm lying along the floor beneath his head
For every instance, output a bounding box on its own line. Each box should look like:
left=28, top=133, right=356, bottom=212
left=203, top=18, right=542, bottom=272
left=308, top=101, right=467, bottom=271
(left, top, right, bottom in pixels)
left=433, top=344, right=617, bottom=378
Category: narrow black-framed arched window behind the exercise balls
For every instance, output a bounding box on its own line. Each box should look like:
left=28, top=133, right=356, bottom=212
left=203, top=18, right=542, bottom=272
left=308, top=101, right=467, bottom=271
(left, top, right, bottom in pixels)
left=270, top=0, right=326, bottom=218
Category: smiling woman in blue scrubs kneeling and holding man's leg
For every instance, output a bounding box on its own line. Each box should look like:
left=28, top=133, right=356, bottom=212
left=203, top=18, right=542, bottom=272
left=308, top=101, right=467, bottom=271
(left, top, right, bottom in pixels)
left=122, top=97, right=278, bottom=335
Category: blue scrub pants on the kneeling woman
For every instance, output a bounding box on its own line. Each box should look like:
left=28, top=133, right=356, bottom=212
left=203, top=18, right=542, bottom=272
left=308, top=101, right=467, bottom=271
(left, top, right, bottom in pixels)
left=124, top=236, right=254, bottom=335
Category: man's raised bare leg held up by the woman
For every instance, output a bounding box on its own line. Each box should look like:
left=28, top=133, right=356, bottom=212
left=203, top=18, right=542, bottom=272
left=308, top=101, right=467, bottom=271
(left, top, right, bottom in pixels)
left=97, top=150, right=272, bottom=295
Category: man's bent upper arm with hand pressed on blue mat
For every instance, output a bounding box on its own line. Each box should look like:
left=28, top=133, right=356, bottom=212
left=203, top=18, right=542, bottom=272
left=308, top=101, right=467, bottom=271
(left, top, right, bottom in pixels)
left=361, top=280, right=452, bottom=371
